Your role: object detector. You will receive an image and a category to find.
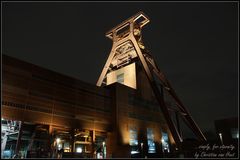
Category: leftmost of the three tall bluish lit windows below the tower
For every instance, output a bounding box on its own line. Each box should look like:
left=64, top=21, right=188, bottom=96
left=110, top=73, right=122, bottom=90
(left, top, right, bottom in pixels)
left=129, top=127, right=139, bottom=154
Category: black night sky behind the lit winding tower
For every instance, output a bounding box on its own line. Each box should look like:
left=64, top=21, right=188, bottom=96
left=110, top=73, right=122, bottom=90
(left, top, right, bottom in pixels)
left=2, top=2, right=238, bottom=136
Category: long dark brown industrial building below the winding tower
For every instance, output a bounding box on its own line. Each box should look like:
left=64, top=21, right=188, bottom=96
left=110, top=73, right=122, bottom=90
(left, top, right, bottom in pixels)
left=1, top=55, right=174, bottom=158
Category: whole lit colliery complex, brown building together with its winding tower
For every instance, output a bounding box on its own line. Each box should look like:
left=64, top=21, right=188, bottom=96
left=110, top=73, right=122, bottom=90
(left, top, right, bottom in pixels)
left=1, top=12, right=206, bottom=158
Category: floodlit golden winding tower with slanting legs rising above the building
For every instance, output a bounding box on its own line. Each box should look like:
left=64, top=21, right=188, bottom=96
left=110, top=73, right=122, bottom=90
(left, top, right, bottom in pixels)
left=97, top=12, right=206, bottom=144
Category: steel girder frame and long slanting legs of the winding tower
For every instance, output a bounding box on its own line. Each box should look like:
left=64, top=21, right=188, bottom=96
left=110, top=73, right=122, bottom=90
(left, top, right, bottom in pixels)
left=97, top=12, right=206, bottom=144
